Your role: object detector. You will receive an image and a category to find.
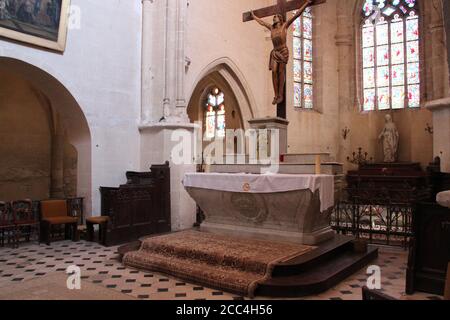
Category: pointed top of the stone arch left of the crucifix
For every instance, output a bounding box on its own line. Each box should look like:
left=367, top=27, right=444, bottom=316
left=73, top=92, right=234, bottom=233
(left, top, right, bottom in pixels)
left=188, top=58, right=257, bottom=129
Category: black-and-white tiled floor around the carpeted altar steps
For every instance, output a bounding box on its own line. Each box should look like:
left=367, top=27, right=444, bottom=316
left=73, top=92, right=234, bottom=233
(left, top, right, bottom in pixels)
left=0, top=241, right=442, bottom=300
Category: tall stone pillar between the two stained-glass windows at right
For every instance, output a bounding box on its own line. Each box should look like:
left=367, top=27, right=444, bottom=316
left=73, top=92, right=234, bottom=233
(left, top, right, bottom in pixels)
left=335, top=0, right=355, bottom=171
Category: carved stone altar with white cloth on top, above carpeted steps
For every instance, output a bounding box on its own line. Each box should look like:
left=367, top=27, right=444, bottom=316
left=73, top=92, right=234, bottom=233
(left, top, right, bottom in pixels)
left=183, top=173, right=334, bottom=245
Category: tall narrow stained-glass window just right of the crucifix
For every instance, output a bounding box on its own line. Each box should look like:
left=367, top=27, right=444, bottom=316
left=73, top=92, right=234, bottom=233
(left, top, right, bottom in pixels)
left=293, top=8, right=314, bottom=109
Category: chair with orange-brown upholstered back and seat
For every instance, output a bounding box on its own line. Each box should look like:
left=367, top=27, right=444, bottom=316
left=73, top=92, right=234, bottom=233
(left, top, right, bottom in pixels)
left=40, top=200, right=78, bottom=245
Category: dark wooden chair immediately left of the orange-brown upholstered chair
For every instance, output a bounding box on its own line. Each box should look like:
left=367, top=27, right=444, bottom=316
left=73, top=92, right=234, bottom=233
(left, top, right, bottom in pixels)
left=11, top=200, right=39, bottom=247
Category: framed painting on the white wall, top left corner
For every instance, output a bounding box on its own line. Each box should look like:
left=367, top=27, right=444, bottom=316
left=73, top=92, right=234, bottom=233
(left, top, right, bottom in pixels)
left=0, top=0, right=70, bottom=52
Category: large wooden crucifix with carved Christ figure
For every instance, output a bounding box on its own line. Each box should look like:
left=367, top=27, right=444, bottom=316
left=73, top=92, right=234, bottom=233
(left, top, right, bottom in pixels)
left=243, top=0, right=326, bottom=119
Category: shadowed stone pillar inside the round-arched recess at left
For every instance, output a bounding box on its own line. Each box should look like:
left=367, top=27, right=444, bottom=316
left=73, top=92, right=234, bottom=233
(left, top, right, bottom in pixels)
left=50, top=115, right=65, bottom=199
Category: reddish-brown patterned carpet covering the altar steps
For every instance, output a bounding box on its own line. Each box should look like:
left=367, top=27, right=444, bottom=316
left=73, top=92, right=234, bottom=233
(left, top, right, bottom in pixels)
left=123, top=230, right=314, bottom=297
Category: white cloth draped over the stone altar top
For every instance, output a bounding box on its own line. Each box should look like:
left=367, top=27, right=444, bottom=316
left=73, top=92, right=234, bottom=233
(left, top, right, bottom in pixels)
left=183, top=173, right=334, bottom=212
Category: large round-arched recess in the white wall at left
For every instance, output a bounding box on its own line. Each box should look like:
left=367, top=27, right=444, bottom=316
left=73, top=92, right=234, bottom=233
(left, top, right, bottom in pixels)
left=0, top=57, right=92, bottom=212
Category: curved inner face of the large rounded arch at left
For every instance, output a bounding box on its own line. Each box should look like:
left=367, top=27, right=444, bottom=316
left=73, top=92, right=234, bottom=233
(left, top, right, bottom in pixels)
left=0, top=57, right=92, bottom=213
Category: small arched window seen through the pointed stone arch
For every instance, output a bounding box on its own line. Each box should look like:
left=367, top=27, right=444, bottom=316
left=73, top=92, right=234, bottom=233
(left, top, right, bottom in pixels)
left=205, top=88, right=226, bottom=139
